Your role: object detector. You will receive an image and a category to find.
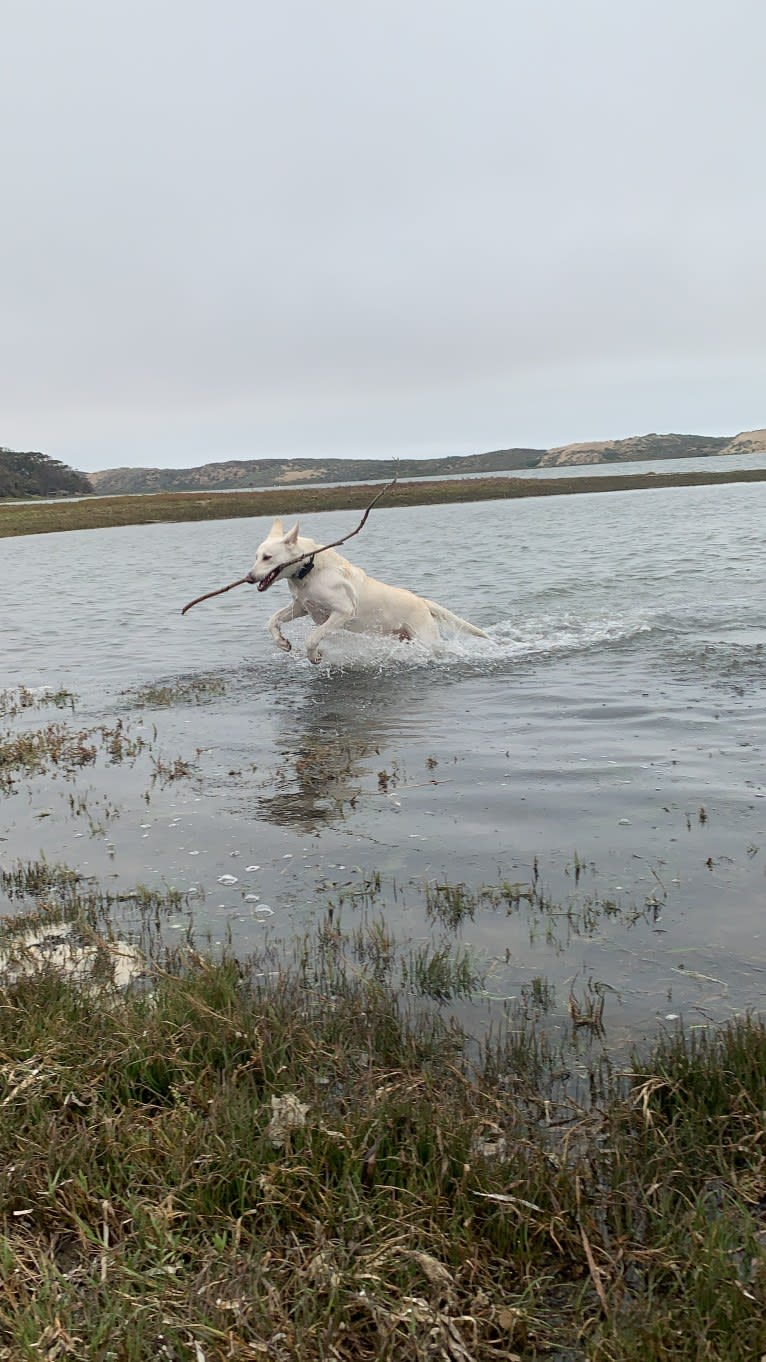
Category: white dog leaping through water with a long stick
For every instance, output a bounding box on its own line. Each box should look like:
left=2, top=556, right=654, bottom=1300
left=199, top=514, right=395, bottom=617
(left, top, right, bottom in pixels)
left=247, top=520, right=487, bottom=662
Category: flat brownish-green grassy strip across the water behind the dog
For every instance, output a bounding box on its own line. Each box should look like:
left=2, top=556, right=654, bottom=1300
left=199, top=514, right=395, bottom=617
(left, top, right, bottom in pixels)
left=0, top=469, right=766, bottom=538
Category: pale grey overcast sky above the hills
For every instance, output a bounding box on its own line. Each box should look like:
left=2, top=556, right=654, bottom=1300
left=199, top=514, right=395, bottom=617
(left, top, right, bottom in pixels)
left=0, top=0, right=766, bottom=471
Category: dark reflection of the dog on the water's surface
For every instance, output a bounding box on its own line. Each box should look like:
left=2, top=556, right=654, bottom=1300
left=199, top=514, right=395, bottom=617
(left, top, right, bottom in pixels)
left=256, top=669, right=436, bottom=832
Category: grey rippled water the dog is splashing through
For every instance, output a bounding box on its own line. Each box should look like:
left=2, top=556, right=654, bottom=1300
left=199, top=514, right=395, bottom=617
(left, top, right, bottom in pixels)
left=0, top=484, right=766, bottom=1035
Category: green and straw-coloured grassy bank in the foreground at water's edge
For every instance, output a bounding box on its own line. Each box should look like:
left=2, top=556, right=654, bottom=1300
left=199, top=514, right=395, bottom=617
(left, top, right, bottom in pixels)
left=0, top=866, right=766, bottom=1362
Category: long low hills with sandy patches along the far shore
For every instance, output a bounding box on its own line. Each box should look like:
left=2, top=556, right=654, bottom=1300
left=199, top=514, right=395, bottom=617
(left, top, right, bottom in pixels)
left=75, top=429, right=766, bottom=496
